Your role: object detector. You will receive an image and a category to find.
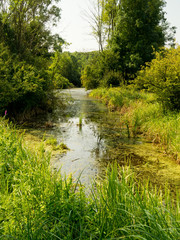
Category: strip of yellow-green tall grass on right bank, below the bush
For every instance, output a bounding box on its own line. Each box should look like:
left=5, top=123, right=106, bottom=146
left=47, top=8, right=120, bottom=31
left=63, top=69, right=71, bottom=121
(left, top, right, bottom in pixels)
left=91, top=88, right=180, bottom=162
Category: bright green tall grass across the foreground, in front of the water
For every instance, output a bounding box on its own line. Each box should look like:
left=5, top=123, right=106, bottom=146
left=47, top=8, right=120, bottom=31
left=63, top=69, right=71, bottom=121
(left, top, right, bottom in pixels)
left=0, top=117, right=180, bottom=240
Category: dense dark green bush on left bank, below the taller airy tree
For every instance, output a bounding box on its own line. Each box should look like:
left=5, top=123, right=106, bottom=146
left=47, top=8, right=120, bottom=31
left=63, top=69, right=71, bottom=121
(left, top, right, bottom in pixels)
left=0, top=44, right=51, bottom=114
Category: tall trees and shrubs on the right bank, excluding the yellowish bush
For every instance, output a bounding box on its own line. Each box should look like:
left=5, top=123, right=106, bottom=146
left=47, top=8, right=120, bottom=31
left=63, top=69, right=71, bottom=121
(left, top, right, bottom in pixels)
left=82, top=0, right=175, bottom=88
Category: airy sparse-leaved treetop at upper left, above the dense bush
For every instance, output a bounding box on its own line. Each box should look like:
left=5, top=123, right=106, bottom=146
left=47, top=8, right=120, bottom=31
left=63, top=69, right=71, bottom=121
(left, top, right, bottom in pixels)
left=0, top=0, right=62, bottom=61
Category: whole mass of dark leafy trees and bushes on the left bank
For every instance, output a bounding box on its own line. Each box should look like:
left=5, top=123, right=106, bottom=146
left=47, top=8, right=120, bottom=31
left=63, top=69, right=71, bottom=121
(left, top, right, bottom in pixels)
left=0, top=0, right=64, bottom=117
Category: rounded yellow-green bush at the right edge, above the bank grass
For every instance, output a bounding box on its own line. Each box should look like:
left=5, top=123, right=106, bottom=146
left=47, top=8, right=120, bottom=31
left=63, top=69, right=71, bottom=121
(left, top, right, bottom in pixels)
left=135, top=47, right=180, bottom=110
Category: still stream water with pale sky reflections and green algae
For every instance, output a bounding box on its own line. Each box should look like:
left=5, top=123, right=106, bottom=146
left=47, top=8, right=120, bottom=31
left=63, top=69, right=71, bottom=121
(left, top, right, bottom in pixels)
left=22, top=89, right=180, bottom=189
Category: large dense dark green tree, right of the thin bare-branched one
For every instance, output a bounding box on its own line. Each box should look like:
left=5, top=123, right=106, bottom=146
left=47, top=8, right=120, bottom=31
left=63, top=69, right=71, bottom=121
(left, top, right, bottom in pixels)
left=110, top=0, right=174, bottom=79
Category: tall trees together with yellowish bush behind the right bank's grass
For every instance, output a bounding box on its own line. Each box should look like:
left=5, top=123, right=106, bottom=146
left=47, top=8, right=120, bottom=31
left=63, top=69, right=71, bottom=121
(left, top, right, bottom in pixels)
left=81, top=0, right=180, bottom=110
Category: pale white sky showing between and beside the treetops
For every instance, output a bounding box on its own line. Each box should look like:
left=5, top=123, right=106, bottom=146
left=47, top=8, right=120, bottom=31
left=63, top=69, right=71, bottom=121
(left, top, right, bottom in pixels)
left=55, top=0, right=180, bottom=52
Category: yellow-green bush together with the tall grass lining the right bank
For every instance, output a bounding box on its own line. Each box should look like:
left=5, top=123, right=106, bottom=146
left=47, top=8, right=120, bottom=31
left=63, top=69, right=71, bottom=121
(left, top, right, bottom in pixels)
left=91, top=46, right=180, bottom=163
